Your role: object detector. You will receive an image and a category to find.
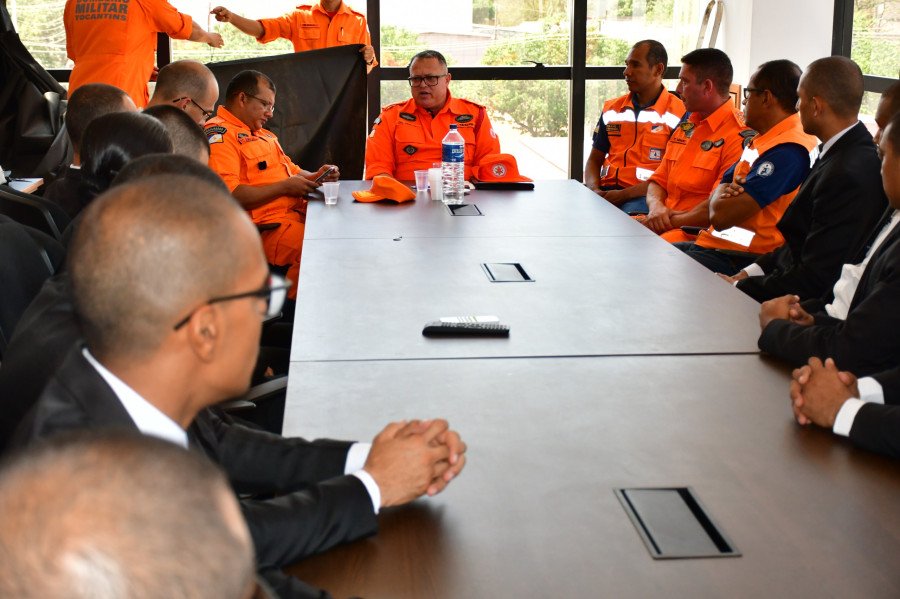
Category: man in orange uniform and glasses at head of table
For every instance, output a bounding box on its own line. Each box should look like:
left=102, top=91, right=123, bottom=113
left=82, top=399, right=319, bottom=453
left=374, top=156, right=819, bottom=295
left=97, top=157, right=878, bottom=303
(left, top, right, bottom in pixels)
left=366, top=50, right=500, bottom=181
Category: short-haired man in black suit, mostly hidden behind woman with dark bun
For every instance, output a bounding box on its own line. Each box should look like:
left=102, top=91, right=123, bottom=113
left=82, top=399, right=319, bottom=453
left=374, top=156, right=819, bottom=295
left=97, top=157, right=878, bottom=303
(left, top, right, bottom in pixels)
left=44, top=83, right=137, bottom=218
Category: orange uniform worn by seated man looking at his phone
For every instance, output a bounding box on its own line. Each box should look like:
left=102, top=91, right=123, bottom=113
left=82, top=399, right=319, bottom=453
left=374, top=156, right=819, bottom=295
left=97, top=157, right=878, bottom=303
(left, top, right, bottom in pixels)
left=204, top=106, right=307, bottom=299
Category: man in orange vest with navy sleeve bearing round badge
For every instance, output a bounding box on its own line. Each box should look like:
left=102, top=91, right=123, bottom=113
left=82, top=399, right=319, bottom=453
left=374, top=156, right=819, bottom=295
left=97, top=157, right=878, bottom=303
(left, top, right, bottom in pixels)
left=676, top=60, right=818, bottom=276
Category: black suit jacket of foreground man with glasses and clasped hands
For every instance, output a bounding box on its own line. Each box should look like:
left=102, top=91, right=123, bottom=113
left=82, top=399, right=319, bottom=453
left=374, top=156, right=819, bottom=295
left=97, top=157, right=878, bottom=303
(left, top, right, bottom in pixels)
left=14, top=347, right=377, bottom=569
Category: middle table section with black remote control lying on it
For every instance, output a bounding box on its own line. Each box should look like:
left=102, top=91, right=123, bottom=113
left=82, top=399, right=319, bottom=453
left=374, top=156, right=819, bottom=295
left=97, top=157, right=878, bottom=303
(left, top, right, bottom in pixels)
left=291, top=236, right=759, bottom=361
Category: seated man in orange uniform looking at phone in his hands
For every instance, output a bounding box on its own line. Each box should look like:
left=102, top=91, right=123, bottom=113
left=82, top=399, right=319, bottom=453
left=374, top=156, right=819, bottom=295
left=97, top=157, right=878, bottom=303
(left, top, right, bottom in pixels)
left=205, top=71, right=339, bottom=299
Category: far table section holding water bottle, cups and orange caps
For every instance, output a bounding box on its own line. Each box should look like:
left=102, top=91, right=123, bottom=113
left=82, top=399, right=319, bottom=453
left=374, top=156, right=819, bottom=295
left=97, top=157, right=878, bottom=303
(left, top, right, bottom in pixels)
left=306, top=180, right=653, bottom=241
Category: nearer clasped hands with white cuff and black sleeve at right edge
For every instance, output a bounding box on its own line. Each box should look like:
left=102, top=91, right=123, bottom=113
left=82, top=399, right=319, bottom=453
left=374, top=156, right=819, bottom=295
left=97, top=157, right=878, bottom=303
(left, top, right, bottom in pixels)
left=791, top=358, right=900, bottom=458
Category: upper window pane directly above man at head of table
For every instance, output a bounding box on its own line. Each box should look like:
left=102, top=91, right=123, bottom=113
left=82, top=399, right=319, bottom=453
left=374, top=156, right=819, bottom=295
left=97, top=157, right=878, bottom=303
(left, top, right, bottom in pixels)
left=376, top=0, right=569, bottom=66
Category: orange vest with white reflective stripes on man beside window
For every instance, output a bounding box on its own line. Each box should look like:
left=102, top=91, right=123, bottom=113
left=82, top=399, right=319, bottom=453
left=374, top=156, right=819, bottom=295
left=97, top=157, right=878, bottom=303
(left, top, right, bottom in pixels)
left=593, top=88, right=684, bottom=189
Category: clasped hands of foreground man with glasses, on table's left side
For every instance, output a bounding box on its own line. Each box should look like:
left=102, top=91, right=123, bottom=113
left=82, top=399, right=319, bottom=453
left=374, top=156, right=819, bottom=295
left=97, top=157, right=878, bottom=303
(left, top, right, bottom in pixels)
left=363, top=419, right=466, bottom=507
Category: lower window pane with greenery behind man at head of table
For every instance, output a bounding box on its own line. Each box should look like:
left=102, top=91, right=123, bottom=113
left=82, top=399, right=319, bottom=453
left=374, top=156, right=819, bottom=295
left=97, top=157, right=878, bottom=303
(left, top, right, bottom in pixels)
left=381, top=81, right=569, bottom=179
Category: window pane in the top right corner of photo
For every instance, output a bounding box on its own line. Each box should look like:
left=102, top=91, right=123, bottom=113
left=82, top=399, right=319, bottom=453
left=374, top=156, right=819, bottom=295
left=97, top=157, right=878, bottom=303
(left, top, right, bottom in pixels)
left=850, top=0, right=900, bottom=77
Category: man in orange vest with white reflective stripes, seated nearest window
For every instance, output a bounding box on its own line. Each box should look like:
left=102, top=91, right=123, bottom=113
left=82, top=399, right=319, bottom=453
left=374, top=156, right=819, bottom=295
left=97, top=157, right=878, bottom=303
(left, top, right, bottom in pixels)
left=584, top=40, right=684, bottom=214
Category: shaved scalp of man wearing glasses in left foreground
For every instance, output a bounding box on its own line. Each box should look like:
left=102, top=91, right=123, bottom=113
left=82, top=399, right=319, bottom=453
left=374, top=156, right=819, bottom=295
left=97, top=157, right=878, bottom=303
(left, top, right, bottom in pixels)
left=68, top=176, right=253, bottom=360
